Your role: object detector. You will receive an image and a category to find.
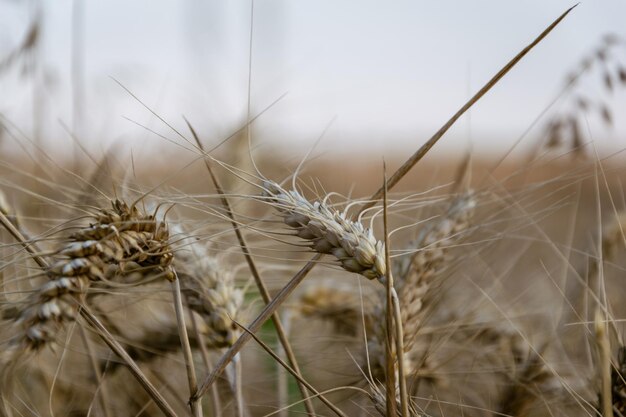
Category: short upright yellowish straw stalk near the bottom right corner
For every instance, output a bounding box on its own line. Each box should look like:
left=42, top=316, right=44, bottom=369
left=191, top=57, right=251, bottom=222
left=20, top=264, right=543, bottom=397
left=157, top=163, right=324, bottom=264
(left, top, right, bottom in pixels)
left=594, top=307, right=615, bottom=417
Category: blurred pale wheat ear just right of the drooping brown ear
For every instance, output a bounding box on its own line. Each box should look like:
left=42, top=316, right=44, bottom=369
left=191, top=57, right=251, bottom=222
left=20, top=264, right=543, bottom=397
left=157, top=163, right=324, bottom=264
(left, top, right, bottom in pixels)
left=176, top=242, right=244, bottom=349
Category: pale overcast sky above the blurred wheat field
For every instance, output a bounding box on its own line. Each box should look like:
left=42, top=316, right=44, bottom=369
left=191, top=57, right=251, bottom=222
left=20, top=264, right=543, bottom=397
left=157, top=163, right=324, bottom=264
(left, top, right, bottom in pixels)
left=0, top=0, right=626, bottom=158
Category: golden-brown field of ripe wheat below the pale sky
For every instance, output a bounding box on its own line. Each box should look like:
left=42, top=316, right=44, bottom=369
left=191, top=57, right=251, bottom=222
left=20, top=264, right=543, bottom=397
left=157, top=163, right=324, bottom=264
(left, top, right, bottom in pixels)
left=0, top=4, right=626, bottom=417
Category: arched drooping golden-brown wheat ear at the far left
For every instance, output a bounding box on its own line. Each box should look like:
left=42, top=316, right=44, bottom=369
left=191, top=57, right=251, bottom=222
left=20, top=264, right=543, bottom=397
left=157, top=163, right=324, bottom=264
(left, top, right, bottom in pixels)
left=10, top=200, right=175, bottom=353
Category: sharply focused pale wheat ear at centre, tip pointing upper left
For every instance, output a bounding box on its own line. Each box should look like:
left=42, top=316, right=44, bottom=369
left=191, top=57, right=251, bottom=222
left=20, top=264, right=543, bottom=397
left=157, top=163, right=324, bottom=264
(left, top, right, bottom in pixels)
left=263, top=181, right=386, bottom=280
